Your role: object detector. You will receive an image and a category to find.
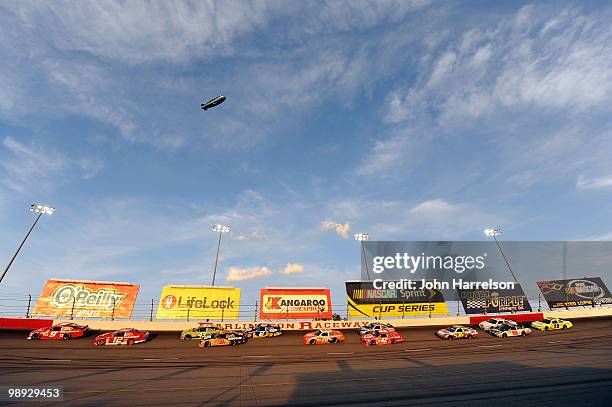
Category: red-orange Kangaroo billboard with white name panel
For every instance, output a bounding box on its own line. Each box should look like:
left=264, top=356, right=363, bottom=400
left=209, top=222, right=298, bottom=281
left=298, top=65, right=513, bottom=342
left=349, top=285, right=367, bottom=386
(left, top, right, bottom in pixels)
left=259, top=288, right=332, bottom=319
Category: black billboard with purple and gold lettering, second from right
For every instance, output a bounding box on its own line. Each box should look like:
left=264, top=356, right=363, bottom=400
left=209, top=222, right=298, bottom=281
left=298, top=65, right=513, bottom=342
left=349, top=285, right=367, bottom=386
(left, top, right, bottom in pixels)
left=457, top=284, right=531, bottom=314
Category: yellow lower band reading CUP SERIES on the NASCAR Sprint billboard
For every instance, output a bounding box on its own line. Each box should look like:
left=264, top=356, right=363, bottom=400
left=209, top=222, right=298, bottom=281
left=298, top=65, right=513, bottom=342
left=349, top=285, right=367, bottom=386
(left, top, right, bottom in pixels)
left=347, top=297, right=448, bottom=318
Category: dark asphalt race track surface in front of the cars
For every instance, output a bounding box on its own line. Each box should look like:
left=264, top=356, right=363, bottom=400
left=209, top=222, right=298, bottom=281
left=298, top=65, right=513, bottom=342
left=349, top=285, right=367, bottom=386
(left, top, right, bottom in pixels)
left=0, top=319, right=612, bottom=406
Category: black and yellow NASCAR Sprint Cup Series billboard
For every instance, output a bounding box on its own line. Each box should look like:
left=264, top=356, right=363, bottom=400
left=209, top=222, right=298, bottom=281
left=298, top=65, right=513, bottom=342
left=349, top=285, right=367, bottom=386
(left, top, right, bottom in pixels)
left=346, top=281, right=448, bottom=318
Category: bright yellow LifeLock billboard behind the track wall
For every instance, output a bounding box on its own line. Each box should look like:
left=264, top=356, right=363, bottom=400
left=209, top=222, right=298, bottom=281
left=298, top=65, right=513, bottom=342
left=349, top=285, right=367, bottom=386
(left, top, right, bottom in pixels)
left=157, top=285, right=240, bottom=320
